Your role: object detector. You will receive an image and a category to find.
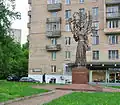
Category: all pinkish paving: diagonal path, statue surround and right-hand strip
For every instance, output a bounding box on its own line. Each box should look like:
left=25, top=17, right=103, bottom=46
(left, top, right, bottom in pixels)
left=2, top=84, right=120, bottom=105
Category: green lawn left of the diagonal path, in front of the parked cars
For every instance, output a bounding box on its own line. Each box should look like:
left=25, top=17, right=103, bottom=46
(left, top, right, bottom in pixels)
left=0, top=81, right=48, bottom=102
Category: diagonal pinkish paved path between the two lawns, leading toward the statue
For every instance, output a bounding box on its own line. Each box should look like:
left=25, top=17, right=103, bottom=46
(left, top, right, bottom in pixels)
left=6, top=90, right=72, bottom=105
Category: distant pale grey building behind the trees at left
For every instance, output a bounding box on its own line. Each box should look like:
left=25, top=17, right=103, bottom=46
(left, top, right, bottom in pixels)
left=10, top=29, right=21, bottom=44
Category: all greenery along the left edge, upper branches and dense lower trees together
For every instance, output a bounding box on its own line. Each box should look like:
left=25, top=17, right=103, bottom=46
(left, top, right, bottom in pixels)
left=0, top=0, right=28, bottom=79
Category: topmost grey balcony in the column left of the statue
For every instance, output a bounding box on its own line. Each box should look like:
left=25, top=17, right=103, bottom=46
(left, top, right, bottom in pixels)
left=47, top=3, right=62, bottom=11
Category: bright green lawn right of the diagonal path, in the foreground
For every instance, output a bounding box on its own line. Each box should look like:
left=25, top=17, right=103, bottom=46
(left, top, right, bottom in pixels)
left=44, top=92, right=120, bottom=105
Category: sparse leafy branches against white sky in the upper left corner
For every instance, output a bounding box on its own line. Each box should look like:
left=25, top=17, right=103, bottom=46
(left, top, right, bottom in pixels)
left=0, top=0, right=20, bottom=37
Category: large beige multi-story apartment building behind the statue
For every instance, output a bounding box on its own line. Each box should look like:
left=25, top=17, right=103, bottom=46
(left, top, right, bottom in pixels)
left=28, top=0, right=120, bottom=83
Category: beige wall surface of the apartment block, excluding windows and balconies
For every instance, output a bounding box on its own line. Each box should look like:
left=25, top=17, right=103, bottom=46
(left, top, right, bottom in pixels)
left=28, top=0, right=120, bottom=82
